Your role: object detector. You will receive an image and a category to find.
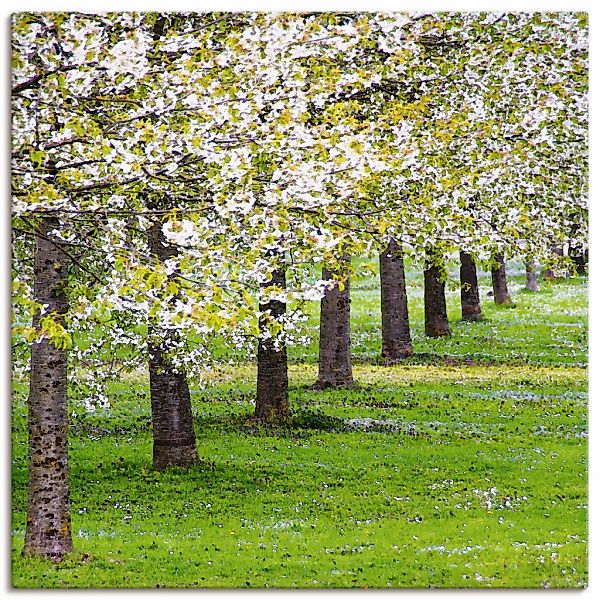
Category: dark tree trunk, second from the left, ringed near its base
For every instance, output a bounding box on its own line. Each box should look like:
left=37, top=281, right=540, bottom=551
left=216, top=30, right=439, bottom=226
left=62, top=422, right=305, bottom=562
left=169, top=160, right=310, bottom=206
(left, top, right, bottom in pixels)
left=148, top=220, right=198, bottom=469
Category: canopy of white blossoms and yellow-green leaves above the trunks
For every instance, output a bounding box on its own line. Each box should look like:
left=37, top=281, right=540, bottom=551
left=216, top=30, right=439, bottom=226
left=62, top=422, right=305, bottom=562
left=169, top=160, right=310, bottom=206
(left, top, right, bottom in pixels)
left=12, top=13, right=587, bottom=380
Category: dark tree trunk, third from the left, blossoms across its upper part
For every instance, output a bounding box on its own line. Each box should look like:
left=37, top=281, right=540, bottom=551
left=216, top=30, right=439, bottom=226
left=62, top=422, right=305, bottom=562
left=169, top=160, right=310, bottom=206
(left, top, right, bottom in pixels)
left=254, top=267, right=290, bottom=423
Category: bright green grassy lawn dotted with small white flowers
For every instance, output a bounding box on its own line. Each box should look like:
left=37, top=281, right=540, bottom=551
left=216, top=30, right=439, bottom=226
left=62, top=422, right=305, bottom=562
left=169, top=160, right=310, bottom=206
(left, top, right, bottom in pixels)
left=12, top=265, right=588, bottom=588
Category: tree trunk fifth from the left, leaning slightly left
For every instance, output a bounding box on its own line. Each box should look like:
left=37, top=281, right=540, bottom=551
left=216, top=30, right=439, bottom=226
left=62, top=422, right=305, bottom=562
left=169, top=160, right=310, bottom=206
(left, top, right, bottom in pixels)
left=379, top=239, right=412, bottom=363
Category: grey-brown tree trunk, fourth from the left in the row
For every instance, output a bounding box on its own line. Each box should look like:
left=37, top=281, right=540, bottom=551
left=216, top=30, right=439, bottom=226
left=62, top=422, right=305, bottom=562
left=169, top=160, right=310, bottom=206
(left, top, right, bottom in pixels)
left=316, top=259, right=354, bottom=388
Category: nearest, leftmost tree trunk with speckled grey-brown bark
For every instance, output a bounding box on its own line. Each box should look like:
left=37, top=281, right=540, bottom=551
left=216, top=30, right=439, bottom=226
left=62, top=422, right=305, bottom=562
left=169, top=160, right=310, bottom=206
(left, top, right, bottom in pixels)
left=23, top=217, right=73, bottom=561
